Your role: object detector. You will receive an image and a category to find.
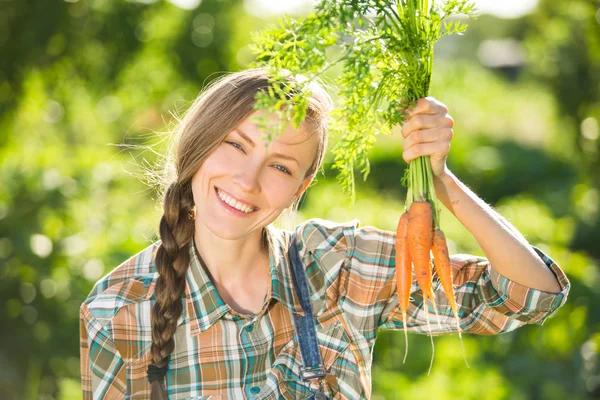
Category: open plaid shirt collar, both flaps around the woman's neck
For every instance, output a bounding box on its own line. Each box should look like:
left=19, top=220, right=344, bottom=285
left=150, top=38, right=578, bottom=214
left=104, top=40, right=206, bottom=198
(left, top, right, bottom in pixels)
left=180, top=226, right=304, bottom=334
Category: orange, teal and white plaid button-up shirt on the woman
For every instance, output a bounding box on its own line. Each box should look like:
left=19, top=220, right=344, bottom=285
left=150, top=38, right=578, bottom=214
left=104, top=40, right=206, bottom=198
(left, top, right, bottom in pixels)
left=80, top=219, right=570, bottom=399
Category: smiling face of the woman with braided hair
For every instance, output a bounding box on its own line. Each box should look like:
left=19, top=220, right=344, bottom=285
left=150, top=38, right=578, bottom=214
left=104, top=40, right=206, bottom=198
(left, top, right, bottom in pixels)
left=192, top=111, right=319, bottom=239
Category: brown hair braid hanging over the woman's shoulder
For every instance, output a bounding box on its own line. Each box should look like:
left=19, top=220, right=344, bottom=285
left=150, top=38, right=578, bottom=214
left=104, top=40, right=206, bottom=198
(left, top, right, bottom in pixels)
left=151, top=182, right=194, bottom=399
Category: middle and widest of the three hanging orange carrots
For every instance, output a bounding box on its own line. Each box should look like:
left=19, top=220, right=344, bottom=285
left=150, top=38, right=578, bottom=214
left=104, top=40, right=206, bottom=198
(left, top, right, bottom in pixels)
left=406, top=201, right=435, bottom=375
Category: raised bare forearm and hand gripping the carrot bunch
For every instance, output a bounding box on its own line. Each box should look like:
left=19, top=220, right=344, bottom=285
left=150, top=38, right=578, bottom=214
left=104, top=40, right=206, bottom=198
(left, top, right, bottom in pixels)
left=402, top=97, right=561, bottom=293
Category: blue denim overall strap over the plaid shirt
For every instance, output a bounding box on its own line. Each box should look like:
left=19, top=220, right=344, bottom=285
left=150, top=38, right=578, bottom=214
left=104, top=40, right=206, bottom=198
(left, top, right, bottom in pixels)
left=289, top=232, right=329, bottom=400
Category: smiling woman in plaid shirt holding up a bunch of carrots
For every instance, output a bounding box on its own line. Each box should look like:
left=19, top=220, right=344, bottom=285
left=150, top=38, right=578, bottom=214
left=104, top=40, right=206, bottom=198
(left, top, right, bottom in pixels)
left=81, top=69, right=569, bottom=399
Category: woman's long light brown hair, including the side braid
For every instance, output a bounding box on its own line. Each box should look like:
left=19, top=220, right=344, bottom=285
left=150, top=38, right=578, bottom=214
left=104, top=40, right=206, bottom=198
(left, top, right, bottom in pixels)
left=146, top=68, right=333, bottom=399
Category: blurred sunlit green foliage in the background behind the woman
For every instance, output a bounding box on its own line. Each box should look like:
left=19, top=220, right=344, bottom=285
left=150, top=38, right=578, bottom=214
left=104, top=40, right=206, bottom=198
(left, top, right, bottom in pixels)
left=0, top=0, right=600, bottom=400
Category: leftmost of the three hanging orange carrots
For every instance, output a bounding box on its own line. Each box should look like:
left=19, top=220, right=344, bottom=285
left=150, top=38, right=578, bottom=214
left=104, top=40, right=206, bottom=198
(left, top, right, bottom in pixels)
left=396, top=212, right=412, bottom=363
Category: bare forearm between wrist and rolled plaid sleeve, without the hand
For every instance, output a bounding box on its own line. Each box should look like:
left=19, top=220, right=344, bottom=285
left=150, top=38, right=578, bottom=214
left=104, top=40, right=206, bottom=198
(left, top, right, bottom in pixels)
left=435, top=172, right=560, bottom=293
